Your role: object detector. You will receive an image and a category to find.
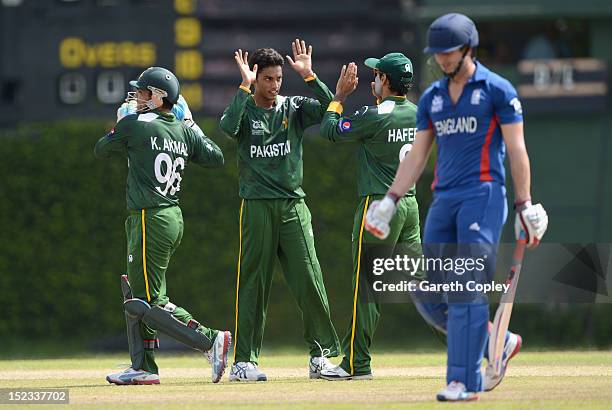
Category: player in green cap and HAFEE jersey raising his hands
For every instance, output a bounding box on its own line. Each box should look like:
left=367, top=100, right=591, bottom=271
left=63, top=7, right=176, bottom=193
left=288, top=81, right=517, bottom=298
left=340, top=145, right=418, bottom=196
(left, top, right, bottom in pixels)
left=321, top=53, right=420, bottom=380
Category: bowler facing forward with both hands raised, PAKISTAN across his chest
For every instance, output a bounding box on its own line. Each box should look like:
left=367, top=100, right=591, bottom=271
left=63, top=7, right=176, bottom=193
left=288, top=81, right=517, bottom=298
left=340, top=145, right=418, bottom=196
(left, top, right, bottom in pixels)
left=220, top=40, right=340, bottom=381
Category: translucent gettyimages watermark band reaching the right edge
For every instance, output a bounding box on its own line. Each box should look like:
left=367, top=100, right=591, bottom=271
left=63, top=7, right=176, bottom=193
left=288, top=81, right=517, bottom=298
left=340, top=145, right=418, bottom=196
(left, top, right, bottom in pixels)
left=358, top=243, right=612, bottom=303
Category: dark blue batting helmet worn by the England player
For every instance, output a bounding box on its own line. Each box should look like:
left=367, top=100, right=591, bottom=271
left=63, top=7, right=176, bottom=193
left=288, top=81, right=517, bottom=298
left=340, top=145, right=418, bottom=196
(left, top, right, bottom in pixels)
left=423, top=13, right=478, bottom=54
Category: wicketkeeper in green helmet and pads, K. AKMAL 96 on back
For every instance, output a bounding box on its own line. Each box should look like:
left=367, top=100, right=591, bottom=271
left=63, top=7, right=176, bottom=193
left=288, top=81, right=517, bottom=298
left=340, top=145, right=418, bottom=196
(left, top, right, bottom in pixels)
left=94, top=67, right=231, bottom=385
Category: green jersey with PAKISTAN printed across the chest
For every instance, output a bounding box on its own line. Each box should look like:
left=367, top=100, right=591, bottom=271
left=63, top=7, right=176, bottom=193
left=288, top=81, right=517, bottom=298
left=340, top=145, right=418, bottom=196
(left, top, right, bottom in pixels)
left=219, top=77, right=333, bottom=199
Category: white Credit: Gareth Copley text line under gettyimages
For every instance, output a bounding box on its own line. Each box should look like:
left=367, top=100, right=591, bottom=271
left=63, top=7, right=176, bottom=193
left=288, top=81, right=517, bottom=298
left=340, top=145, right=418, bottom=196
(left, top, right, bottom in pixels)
left=372, top=280, right=510, bottom=293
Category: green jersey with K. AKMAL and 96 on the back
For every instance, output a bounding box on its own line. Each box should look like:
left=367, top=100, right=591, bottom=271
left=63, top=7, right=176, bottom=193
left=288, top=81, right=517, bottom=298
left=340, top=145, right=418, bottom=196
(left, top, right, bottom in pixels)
left=94, top=111, right=223, bottom=210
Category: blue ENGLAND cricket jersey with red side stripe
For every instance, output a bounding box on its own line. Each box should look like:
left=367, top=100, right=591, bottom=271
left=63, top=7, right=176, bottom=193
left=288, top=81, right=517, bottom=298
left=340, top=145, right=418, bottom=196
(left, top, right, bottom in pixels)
left=417, top=62, right=523, bottom=191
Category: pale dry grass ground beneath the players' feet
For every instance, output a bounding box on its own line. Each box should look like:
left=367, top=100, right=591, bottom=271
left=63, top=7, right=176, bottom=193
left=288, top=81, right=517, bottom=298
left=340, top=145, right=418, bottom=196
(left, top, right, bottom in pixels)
left=0, top=351, right=612, bottom=410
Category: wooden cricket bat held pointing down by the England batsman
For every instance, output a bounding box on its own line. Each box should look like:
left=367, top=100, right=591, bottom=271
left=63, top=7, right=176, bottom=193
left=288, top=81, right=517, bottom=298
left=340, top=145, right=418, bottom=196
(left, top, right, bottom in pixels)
left=487, top=233, right=526, bottom=376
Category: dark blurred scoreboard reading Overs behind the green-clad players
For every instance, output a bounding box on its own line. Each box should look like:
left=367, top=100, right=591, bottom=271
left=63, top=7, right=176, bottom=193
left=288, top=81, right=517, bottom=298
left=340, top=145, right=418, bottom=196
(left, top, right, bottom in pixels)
left=0, top=0, right=421, bottom=126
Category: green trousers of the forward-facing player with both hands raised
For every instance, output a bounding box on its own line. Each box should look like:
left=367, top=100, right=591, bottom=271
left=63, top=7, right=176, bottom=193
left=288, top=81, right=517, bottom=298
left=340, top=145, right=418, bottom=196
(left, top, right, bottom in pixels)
left=234, top=198, right=340, bottom=364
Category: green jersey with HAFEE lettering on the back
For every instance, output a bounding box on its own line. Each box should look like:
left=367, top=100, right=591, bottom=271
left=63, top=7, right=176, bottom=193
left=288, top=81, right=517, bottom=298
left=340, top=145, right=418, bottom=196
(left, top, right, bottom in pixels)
left=321, top=96, right=417, bottom=196
